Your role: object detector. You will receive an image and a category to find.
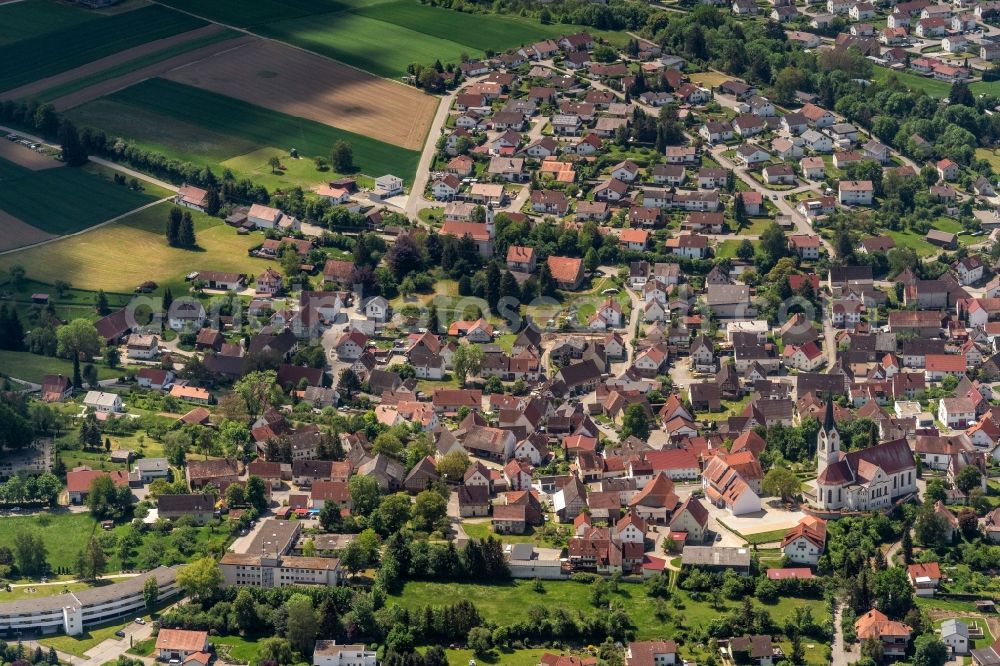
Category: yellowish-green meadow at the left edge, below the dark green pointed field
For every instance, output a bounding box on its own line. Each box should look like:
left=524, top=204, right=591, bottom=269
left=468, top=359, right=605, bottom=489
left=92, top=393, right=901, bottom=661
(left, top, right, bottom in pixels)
left=0, top=200, right=273, bottom=296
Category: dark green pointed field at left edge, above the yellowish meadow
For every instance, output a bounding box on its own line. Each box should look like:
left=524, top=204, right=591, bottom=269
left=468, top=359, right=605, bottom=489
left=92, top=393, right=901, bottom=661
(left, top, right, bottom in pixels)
left=0, top=159, right=153, bottom=235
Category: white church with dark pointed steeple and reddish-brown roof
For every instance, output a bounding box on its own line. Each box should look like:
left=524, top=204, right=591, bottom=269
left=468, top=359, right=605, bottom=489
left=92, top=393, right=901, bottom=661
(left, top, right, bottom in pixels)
left=815, top=397, right=917, bottom=511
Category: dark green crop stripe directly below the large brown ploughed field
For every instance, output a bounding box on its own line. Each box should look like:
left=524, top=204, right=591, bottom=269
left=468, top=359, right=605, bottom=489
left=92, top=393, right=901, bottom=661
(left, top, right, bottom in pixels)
left=98, top=79, right=420, bottom=181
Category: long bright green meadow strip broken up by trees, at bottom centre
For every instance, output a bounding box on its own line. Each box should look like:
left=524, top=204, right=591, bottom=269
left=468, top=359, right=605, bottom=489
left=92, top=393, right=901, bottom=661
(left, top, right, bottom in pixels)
left=387, top=581, right=827, bottom=640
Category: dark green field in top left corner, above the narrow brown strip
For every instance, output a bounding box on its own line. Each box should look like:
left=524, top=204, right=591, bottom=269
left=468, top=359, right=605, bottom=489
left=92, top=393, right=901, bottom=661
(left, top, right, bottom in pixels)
left=0, top=5, right=205, bottom=90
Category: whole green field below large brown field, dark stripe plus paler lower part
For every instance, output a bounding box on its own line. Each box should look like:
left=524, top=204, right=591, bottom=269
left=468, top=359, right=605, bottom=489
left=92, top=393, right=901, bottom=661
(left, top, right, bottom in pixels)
left=69, top=79, right=420, bottom=182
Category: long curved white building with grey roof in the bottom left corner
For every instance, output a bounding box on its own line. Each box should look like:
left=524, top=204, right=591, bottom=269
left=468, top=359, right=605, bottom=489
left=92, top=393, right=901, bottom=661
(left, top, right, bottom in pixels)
left=0, top=567, right=180, bottom=636
